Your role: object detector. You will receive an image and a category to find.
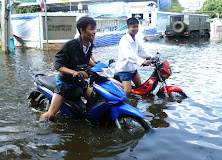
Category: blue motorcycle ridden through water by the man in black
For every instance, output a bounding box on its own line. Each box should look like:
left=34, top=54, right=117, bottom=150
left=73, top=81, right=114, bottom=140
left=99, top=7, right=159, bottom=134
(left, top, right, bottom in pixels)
left=28, top=62, right=151, bottom=132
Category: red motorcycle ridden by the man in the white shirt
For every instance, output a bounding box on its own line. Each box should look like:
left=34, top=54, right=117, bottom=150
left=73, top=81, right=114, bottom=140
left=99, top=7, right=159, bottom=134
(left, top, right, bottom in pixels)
left=106, top=53, right=187, bottom=98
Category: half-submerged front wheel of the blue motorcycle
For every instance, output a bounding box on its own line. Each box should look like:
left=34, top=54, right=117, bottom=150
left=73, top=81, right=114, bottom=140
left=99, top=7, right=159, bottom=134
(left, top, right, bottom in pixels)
left=117, top=115, right=151, bottom=133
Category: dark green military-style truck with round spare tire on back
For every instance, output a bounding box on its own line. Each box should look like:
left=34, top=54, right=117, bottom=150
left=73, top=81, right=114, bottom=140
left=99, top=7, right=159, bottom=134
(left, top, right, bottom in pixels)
left=165, top=14, right=210, bottom=38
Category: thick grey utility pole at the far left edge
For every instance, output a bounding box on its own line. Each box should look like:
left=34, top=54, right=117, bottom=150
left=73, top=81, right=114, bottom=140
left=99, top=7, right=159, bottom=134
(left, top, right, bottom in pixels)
left=1, top=0, right=10, bottom=54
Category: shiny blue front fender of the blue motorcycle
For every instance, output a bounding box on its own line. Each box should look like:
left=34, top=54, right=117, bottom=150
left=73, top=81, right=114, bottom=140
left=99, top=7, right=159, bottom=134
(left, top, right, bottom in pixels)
left=110, top=103, right=145, bottom=121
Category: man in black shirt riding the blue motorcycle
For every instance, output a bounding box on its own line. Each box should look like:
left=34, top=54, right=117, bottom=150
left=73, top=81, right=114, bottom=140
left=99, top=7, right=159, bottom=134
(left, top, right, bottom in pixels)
left=40, top=17, right=96, bottom=119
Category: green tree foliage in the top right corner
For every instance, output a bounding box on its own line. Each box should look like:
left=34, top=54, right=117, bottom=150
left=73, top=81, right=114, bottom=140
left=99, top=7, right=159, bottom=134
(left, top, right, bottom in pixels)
left=199, top=0, right=222, bottom=18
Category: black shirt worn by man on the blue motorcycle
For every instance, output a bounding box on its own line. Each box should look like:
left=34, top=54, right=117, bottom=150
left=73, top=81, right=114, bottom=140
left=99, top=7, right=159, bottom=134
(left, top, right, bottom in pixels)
left=54, top=37, right=93, bottom=85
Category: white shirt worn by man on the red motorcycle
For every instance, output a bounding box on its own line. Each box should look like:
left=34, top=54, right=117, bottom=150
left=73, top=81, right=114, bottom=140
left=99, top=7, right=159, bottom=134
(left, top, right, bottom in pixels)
left=115, top=33, right=153, bottom=72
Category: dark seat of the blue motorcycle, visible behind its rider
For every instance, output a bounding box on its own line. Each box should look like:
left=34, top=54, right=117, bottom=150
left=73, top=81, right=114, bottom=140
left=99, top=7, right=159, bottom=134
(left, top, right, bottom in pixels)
left=38, top=75, right=56, bottom=91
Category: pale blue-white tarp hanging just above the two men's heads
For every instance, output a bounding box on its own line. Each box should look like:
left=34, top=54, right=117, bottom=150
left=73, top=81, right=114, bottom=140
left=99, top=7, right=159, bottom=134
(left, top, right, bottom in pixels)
left=88, top=2, right=130, bottom=18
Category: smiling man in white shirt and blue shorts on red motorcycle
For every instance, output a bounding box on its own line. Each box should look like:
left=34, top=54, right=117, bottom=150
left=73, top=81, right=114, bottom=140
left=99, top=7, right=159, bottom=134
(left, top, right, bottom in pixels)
left=115, top=18, right=156, bottom=95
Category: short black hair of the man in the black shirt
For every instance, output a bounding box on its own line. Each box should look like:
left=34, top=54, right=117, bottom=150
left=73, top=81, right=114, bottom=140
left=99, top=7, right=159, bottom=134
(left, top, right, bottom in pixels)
left=77, top=16, right=96, bottom=34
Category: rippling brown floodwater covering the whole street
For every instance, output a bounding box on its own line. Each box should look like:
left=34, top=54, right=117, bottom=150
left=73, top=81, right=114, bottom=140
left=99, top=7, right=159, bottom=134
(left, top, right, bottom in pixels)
left=0, top=34, right=222, bottom=160
